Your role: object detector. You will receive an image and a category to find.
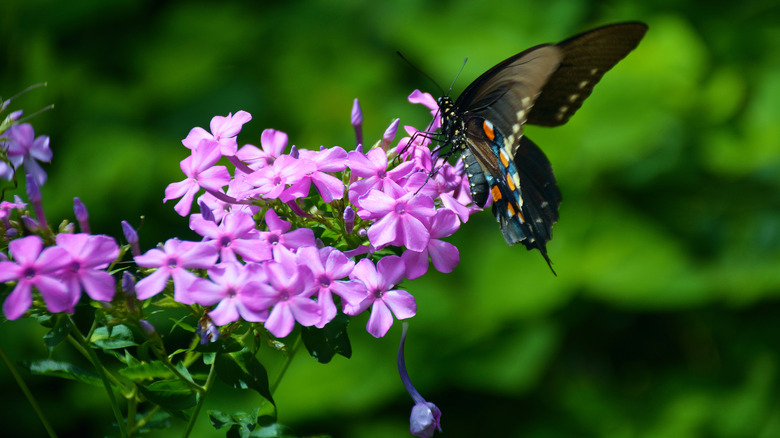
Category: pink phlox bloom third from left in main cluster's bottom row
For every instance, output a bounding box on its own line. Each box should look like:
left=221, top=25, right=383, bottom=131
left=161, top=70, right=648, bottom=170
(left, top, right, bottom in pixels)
left=260, top=247, right=322, bottom=338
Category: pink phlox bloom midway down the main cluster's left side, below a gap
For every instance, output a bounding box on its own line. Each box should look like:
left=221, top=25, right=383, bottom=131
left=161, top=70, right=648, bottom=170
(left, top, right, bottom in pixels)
left=190, top=211, right=271, bottom=262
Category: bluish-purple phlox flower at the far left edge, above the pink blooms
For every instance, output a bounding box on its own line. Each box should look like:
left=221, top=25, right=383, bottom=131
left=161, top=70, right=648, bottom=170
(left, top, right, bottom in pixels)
left=0, top=123, right=52, bottom=186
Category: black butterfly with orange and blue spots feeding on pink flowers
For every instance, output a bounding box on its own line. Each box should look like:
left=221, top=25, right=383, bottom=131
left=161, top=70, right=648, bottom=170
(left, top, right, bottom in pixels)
left=439, top=22, right=647, bottom=273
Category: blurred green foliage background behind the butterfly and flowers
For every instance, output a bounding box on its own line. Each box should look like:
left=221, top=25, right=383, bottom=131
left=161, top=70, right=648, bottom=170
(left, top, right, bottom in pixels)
left=0, top=0, right=780, bottom=437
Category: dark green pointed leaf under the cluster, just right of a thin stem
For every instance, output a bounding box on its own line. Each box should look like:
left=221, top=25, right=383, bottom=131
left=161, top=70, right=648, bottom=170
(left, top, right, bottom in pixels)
left=215, top=348, right=274, bottom=403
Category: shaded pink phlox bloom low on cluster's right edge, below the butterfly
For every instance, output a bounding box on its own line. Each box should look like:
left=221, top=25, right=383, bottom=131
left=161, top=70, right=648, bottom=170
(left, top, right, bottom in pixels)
left=401, top=209, right=460, bottom=280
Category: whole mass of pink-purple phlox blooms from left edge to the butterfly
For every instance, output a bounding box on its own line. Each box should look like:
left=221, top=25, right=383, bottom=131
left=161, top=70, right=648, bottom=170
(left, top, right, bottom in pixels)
left=0, top=91, right=476, bottom=337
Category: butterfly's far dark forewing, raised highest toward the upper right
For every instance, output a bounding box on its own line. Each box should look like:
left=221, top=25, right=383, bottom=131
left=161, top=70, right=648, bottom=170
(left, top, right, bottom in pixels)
left=527, top=22, right=647, bottom=126
